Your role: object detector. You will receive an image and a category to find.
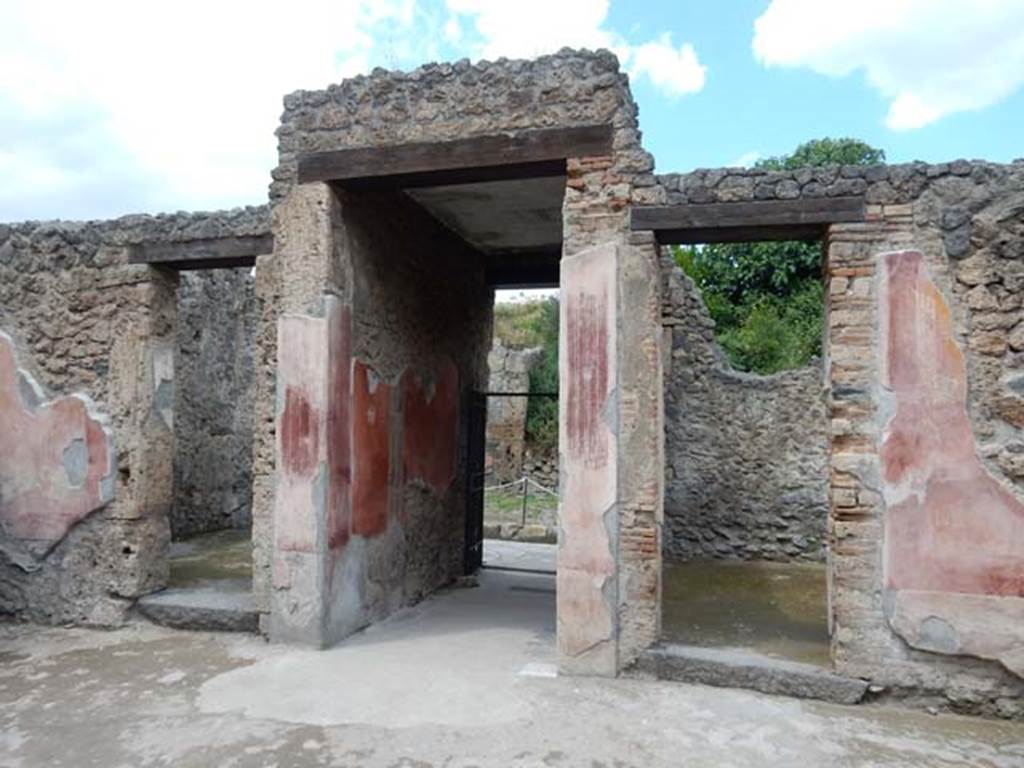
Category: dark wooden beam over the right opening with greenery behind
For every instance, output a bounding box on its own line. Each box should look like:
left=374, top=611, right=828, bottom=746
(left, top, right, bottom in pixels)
left=630, top=197, right=864, bottom=244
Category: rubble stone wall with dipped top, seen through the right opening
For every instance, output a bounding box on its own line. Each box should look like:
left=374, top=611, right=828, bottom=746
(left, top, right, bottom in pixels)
left=662, top=253, right=828, bottom=560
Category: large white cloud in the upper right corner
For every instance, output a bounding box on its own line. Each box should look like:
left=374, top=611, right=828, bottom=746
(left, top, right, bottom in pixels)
left=754, top=0, right=1024, bottom=130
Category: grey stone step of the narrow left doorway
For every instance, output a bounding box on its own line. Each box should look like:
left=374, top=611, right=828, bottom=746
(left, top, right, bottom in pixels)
left=135, top=584, right=259, bottom=632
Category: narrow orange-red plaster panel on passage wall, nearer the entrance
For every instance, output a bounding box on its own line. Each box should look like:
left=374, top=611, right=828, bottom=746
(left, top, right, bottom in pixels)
left=352, top=360, right=391, bottom=537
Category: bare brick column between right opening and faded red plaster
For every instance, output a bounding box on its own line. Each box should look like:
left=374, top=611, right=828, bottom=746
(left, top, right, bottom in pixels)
left=825, top=206, right=912, bottom=677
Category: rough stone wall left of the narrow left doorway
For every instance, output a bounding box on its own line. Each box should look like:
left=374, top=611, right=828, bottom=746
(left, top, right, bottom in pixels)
left=0, top=209, right=266, bottom=625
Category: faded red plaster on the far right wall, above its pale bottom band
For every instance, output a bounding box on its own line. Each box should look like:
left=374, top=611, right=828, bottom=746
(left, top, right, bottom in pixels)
left=881, top=251, right=1024, bottom=596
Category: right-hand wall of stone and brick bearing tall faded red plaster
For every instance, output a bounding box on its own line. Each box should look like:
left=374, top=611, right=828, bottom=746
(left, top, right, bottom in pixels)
left=652, top=161, right=1024, bottom=717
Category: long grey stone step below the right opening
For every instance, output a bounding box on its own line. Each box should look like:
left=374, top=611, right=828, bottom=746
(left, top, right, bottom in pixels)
left=638, top=644, right=867, bottom=705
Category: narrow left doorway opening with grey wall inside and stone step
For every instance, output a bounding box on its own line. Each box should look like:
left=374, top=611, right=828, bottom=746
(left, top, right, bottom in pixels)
left=138, top=262, right=258, bottom=632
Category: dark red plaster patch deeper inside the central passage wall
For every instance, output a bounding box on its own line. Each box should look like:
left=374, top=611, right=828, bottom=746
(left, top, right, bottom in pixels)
left=401, top=359, right=459, bottom=494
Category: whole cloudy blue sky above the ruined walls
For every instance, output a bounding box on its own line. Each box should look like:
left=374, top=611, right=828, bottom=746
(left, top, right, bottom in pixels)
left=0, top=0, right=1024, bottom=221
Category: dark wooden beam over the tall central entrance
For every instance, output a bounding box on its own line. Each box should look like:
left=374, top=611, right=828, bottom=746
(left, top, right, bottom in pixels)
left=298, top=125, right=612, bottom=187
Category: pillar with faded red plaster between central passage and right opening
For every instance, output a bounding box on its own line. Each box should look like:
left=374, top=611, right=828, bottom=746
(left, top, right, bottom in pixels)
left=558, top=147, right=665, bottom=676
